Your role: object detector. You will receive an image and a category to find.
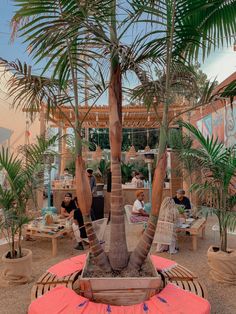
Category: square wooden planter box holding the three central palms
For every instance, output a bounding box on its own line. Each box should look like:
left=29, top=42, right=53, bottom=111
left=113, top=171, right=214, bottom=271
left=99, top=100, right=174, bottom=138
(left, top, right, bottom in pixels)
left=79, top=255, right=162, bottom=305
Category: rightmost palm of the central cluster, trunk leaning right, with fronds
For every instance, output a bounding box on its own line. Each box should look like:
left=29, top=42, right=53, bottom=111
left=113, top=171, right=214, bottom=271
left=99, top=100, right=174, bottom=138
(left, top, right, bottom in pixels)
left=129, top=0, right=236, bottom=267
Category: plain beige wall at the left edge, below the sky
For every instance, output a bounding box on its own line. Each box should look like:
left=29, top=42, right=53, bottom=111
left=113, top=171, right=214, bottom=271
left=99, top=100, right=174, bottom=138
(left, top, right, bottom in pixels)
left=0, top=68, right=39, bottom=151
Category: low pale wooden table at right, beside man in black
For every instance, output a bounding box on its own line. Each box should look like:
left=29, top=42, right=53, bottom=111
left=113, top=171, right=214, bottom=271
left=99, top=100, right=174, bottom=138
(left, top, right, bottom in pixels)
left=176, top=218, right=206, bottom=251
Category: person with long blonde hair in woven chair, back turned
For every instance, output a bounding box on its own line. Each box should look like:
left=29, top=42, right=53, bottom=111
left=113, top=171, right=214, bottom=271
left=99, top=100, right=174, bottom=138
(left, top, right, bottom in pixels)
left=157, top=197, right=179, bottom=254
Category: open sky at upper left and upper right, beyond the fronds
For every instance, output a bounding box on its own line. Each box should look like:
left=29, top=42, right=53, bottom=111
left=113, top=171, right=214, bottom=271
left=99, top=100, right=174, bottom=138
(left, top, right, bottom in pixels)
left=0, top=0, right=236, bottom=93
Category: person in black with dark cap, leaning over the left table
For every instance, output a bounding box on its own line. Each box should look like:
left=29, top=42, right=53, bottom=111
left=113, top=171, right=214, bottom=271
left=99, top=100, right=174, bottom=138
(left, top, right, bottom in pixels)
left=61, top=193, right=87, bottom=250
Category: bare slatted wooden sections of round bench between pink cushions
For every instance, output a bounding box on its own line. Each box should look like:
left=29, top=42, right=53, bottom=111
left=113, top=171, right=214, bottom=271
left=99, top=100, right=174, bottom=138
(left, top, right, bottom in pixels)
left=31, top=264, right=207, bottom=301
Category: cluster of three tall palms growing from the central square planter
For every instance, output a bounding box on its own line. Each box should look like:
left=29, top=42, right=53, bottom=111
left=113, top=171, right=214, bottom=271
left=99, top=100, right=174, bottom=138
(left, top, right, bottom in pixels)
left=3, top=0, right=236, bottom=270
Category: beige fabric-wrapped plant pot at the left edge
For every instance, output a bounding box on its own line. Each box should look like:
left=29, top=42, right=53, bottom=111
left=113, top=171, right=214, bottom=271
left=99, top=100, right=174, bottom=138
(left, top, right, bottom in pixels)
left=1, top=249, right=32, bottom=286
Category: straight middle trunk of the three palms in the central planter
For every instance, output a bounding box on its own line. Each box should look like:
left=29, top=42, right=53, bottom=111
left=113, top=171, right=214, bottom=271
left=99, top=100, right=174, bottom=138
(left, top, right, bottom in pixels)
left=109, top=63, right=128, bottom=270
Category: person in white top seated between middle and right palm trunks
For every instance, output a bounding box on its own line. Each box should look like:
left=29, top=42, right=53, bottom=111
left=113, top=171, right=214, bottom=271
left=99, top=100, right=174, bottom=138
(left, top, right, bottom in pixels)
left=130, top=190, right=149, bottom=222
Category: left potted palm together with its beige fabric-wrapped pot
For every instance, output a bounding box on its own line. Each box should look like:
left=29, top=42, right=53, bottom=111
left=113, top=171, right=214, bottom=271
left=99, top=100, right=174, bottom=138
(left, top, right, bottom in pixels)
left=0, top=136, right=57, bottom=285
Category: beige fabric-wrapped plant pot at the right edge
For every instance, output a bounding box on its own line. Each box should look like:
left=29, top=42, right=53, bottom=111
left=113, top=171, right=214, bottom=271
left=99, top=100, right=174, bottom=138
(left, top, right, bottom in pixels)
left=207, top=246, right=236, bottom=285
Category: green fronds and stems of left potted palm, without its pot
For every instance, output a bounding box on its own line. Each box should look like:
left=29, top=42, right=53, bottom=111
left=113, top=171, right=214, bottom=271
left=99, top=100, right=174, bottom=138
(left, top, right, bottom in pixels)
left=0, top=136, right=58, bottom=258
